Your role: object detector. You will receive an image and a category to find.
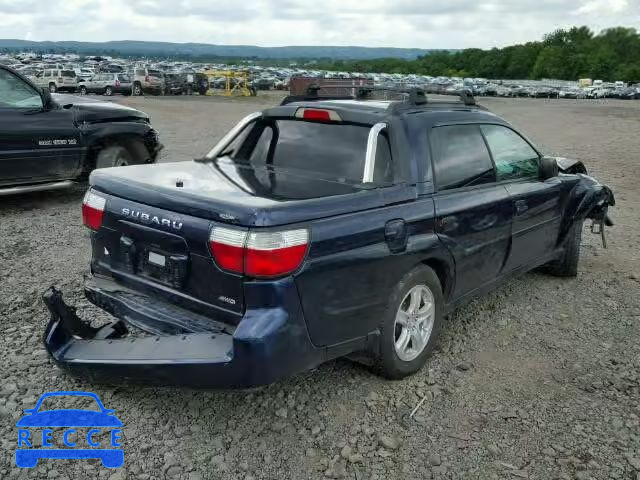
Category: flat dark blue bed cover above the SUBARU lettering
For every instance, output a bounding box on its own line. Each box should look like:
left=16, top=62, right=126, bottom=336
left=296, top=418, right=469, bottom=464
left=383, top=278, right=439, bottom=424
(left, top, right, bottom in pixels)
left=90, top=159, right=408, bottom=227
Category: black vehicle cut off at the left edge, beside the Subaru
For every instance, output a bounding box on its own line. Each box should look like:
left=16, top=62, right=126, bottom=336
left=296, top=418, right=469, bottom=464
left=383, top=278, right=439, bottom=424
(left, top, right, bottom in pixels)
left=0, top=65, right=162, bottom=195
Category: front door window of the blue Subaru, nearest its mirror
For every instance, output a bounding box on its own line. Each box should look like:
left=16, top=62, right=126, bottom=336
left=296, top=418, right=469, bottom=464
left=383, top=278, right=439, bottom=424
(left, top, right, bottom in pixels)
left=480, top=125, right=539, bottom=181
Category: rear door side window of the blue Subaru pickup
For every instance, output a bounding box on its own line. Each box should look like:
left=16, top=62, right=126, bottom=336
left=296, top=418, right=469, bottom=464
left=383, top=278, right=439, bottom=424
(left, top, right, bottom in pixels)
left=430, top=125, right=496, bottom=190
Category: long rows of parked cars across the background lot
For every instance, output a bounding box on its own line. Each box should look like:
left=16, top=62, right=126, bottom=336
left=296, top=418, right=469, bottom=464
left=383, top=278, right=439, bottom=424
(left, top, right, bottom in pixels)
left=2, top=55, right=640, bottom=99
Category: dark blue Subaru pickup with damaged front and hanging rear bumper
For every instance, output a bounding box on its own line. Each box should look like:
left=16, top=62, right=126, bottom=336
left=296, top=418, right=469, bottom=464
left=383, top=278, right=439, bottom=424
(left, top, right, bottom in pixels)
left=44, top=90, right=614, bottom=387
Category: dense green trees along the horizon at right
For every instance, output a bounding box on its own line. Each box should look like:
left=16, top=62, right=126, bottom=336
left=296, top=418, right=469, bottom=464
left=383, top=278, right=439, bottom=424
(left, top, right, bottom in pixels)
left=315, top=27, right=640, bottom=83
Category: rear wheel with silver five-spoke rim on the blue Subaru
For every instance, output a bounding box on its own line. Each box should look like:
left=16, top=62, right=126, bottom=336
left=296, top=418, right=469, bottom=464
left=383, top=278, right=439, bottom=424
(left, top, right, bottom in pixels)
left=374, top=266, right=444, bottom=380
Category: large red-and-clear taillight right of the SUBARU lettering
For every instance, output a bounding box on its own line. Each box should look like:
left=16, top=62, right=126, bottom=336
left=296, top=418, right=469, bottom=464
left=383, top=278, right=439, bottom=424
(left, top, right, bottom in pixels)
left=209, top=227, right=309, bottom=278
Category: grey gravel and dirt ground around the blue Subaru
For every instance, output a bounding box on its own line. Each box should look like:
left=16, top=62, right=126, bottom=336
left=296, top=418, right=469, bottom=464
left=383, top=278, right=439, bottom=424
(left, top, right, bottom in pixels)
left=0, top=94, right=640, bottom=480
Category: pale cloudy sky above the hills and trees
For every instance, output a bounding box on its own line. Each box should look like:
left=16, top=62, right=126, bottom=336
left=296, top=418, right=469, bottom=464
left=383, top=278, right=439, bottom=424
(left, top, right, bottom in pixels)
left=0, top=0, right=640, bottom=49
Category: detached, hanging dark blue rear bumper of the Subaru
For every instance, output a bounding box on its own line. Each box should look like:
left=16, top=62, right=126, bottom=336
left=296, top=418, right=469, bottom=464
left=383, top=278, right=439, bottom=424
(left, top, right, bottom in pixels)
left=43, top=280, right=326, bottom=388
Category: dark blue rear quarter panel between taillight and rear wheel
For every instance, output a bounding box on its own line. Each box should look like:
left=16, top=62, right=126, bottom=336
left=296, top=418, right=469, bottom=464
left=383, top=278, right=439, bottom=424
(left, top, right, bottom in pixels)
left=296, top=197, right=453, bottom=346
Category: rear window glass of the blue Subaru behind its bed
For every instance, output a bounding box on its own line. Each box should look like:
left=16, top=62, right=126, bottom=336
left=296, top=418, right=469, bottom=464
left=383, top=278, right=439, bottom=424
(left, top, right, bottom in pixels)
left=223, top=119, right=393, bottom=184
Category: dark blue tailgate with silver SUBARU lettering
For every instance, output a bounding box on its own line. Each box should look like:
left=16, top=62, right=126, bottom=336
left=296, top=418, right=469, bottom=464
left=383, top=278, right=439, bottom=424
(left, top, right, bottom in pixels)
left=91, top=194, right=244, bottom=324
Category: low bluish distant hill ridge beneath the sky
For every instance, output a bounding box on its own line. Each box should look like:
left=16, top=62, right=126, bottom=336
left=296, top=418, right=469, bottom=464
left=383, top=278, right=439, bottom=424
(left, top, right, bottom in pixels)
left=0, top=39, right=432, bottom=60
